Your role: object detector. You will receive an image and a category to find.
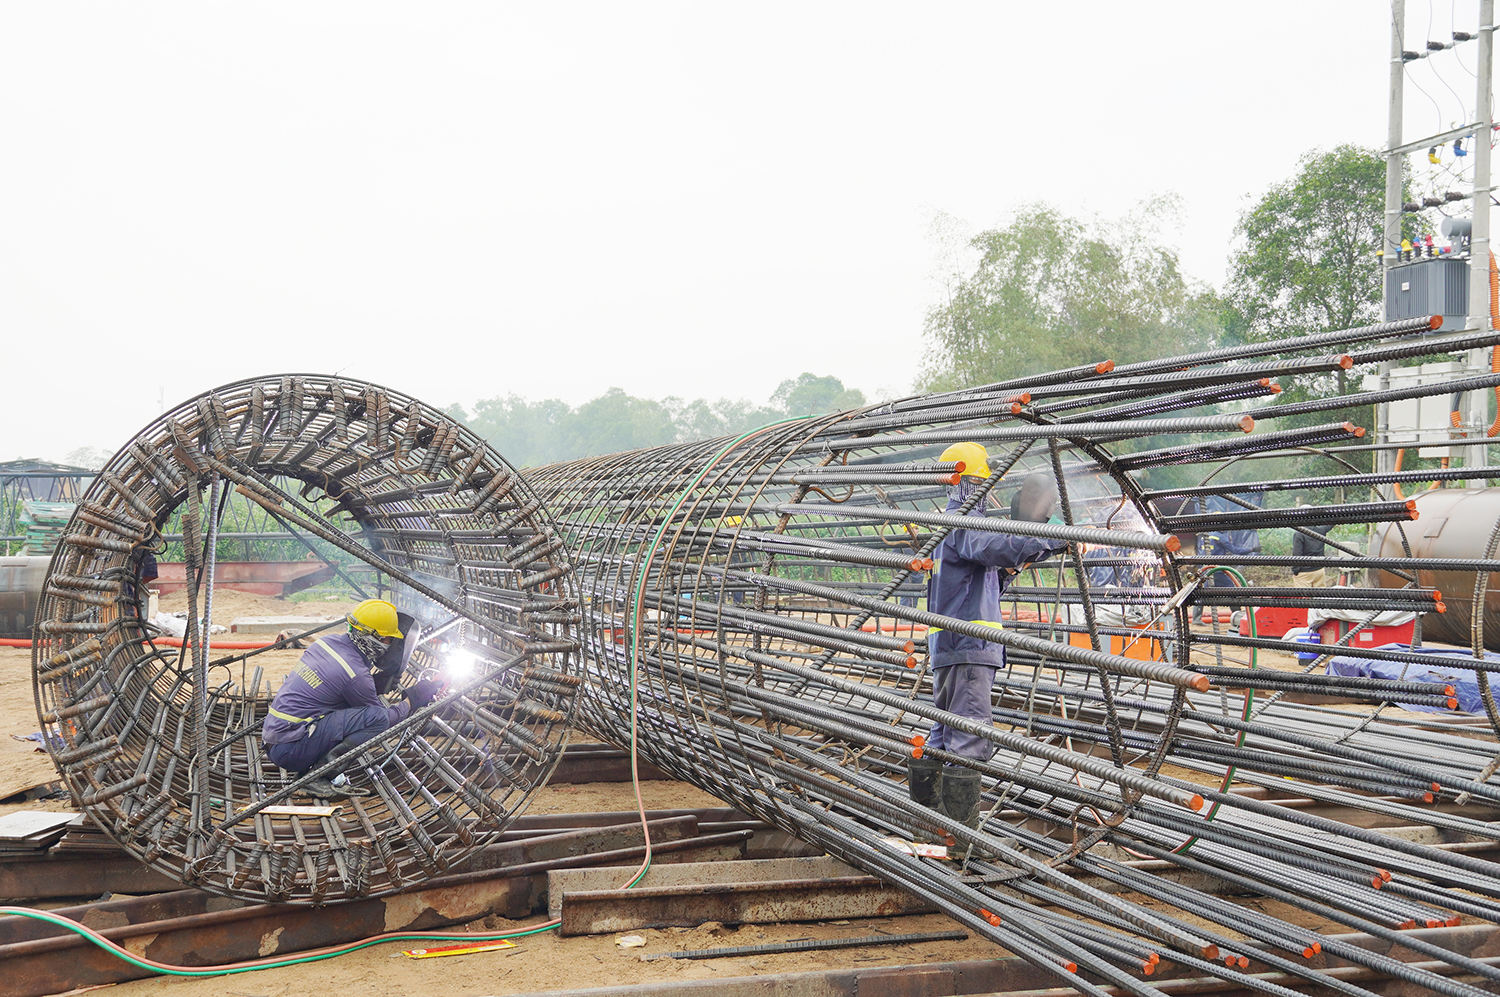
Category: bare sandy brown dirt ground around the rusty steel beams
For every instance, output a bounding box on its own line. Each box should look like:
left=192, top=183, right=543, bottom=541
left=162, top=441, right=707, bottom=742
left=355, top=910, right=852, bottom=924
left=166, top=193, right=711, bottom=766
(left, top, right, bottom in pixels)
left=0, top=591, right=1428, bottom=997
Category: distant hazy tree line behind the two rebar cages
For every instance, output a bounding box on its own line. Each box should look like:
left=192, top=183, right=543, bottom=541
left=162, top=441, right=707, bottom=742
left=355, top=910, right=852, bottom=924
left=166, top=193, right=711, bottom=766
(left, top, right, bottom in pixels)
left=447, top=373, right=864, bottom=468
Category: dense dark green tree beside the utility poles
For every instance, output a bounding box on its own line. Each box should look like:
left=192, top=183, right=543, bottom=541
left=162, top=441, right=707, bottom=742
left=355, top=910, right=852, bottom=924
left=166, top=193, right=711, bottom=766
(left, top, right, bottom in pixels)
left=1226, top=145, right=1386, bottom=340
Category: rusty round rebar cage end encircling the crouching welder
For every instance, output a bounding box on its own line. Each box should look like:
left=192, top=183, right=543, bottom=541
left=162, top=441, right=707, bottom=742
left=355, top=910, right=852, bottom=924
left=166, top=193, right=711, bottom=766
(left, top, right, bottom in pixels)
left=33, top=375, right=581, bottom=903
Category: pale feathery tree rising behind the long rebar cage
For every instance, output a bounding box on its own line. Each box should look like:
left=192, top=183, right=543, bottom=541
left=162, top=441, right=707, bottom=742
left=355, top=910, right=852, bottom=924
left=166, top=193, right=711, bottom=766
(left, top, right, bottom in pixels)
left=918, top=198, right=1220, bottom=390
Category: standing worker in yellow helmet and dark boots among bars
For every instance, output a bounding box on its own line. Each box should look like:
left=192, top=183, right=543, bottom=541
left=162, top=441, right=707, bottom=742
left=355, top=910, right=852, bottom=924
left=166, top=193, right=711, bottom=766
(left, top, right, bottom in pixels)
left=908, top=442, right=1068, bottom=828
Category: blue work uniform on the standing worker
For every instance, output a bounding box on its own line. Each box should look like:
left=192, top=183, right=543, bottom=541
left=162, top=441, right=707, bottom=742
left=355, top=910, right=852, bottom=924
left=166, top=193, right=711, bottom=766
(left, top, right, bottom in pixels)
left=927, top=483, right=1068, bottom=762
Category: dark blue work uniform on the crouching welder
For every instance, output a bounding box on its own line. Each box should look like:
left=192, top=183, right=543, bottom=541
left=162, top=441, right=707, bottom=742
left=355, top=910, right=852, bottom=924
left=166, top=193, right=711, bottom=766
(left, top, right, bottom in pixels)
left=261, top=634, right=411, bottom=772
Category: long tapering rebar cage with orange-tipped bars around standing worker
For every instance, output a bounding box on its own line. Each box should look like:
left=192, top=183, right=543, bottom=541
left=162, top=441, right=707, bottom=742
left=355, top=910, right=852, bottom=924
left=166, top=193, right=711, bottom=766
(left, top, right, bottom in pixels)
left=527, top=319, right=1500, bottom=994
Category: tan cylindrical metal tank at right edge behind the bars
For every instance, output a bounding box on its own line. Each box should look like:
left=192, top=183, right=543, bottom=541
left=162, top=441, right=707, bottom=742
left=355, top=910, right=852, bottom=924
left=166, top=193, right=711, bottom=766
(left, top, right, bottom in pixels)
left=1373, top=487, right=1500, bottom=651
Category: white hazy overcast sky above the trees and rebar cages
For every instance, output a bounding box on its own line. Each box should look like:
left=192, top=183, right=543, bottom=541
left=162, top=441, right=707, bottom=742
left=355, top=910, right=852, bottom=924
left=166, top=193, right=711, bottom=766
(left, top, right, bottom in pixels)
left=0, top=0, right=1478, bottom=459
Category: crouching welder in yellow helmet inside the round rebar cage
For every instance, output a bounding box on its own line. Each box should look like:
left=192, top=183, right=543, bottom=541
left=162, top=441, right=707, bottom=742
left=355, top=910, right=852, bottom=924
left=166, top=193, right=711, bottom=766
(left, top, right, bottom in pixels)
left=261, top=598, right=441, bottom=798
